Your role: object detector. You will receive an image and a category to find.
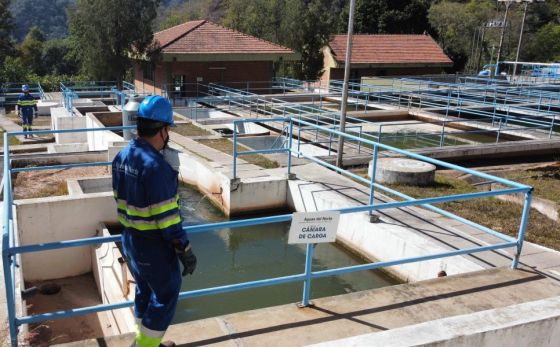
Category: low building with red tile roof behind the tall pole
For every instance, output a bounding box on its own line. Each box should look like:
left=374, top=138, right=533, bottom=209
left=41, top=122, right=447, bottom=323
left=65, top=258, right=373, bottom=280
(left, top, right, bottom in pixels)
left=321, top=35, right=453, bottom=85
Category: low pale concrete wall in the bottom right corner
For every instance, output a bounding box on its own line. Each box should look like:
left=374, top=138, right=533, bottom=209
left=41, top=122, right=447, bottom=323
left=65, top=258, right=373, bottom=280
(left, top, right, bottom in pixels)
left=313, top=297, right=560, bottom=347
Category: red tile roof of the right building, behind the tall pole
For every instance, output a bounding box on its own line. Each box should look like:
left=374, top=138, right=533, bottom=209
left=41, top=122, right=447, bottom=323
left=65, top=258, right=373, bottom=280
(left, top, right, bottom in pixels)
left=329, top=35, right=452, bottom=65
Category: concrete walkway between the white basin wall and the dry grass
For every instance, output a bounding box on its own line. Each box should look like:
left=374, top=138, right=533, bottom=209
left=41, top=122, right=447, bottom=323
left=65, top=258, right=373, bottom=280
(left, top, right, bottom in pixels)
left=280, top=164, right=560, bottom=281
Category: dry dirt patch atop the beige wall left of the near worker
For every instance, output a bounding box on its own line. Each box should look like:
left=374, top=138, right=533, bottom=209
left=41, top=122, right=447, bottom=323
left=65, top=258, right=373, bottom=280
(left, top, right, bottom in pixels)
left=13, top=167, right=110, bottom=199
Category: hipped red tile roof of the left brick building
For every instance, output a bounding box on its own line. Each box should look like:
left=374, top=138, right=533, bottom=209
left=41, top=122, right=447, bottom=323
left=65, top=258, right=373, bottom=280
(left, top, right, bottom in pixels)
left=154, top=20, right=294, bottom=54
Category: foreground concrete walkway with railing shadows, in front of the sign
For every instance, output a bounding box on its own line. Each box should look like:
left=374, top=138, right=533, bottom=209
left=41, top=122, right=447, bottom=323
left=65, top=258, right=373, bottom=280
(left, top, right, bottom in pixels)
left=55, top=269, right=560, bottom=347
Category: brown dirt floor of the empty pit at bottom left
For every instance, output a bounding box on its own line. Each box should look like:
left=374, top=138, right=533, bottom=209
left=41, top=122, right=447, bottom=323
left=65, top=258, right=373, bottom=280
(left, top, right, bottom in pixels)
left=26, top=273, right=108, bottom=347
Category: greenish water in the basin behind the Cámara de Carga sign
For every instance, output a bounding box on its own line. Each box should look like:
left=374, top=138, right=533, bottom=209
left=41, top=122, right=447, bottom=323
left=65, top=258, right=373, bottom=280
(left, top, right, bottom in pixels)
left=174, top=186, right=396, bottom=323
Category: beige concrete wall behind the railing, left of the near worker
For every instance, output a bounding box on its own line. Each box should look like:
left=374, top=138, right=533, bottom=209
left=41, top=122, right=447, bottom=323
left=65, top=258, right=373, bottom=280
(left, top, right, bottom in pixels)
left=15, top=193, right=117, bottom=281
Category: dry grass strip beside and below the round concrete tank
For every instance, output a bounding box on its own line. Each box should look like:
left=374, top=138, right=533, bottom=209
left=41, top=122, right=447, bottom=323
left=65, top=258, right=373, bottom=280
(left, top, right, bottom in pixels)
left=357, top=171, right=560, bottom=250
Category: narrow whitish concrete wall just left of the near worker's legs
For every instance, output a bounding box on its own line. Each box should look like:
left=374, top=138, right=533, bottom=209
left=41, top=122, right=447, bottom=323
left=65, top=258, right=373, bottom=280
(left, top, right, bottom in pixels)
left=91, top=224, right=135, bottom=334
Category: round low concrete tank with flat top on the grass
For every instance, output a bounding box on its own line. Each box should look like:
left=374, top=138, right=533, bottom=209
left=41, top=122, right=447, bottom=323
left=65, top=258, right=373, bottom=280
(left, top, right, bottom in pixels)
left=368, top=158, right=436, bottom=186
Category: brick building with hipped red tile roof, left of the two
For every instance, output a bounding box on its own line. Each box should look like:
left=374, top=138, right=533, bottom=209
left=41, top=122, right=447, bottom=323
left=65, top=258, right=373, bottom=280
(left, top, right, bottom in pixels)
left=134, top=20, right=299, bottom=96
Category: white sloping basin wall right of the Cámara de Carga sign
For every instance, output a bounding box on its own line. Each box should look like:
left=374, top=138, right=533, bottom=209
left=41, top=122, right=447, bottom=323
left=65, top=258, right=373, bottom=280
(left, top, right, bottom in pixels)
left=288, top=181, right=483, bottom=282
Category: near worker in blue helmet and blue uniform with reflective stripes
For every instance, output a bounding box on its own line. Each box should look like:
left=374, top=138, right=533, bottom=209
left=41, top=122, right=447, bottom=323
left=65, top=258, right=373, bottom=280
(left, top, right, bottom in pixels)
left=112, top=96, right=196, bottom=347
